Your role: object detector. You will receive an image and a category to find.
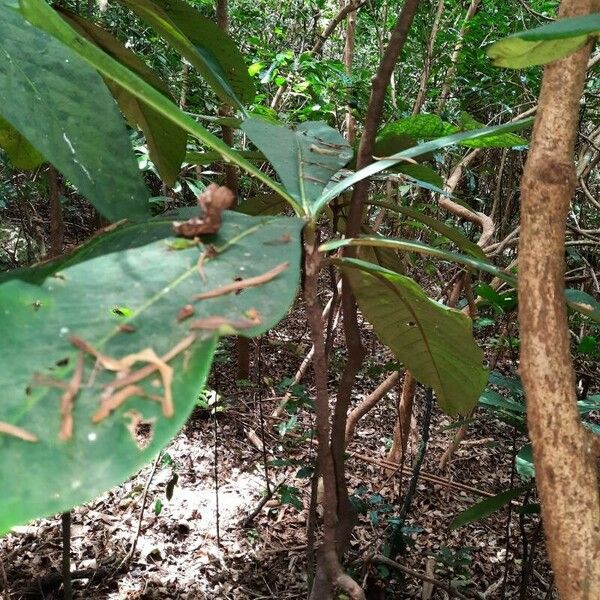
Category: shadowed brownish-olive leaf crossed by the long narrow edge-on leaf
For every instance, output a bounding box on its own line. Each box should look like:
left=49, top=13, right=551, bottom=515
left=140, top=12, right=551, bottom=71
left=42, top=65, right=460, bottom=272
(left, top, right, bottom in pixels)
left=57, top=8, right=187, bottom=186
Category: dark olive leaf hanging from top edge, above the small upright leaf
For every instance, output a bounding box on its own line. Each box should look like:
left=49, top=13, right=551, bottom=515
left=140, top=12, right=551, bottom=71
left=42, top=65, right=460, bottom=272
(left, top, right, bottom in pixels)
left=119, top=0, right=255, bottom=109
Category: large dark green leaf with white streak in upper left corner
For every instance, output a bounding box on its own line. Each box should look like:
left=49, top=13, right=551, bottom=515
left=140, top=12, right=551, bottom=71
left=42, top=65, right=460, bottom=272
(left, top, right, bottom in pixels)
left=0, top=0, right=148, bottom=220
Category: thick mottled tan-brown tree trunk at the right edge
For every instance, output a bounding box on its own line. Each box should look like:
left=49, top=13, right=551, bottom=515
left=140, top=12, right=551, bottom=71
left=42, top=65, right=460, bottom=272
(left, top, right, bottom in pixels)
left=519, top=0, right=600, bottom=600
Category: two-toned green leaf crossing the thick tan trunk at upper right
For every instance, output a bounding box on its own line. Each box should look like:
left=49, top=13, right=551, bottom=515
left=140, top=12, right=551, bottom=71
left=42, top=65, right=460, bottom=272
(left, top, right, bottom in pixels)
left=487, top=13, right=600, bottom=69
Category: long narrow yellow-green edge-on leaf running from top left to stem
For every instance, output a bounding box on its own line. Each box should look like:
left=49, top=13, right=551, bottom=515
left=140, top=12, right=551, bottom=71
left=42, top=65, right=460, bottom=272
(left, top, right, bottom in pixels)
left=19, top=0, right=302, bottom=214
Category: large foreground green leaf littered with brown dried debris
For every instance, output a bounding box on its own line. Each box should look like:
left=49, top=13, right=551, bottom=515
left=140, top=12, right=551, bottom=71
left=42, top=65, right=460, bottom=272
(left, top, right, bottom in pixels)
left=0, top=209, right=302, bottom=532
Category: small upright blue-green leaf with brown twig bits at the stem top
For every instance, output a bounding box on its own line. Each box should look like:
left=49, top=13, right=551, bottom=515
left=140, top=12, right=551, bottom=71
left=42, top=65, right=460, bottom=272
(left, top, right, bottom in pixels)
left=242, top=117, right=352, bottom=214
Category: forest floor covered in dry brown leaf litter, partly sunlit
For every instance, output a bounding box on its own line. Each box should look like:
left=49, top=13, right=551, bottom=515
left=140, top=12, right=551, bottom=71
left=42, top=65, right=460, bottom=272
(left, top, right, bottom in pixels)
left=0, top=308, right=552, bottom=600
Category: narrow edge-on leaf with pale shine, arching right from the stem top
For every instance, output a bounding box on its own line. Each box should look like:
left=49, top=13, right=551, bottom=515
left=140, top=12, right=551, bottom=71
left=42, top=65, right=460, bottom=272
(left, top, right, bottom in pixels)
left=313, top=118, right=533, bottom=214
